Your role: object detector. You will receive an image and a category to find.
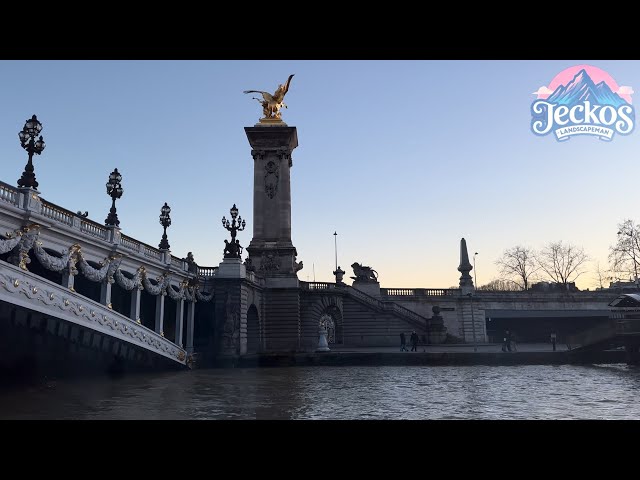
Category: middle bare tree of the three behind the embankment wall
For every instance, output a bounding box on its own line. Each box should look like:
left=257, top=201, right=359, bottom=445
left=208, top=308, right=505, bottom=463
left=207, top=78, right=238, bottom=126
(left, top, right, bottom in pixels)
left=536, top=241, right=589, bottom=288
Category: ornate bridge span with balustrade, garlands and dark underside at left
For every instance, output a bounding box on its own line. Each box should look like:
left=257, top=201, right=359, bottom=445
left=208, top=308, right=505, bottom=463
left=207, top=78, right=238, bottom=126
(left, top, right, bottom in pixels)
left=0, top=177, right=216, bottom=378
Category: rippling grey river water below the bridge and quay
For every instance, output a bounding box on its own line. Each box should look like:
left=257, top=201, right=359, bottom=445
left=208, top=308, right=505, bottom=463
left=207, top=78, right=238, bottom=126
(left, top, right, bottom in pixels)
left=0, top=365, right=640, bottom=419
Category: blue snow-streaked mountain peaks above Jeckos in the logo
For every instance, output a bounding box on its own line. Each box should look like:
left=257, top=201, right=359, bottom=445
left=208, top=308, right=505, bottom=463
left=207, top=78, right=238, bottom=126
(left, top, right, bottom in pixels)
left=547, top=69, right=628, bottom=107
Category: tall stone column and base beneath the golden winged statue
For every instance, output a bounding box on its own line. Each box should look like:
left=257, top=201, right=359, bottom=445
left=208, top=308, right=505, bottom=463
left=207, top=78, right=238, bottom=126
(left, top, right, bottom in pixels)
left=245, top=122, right=302, bottom=351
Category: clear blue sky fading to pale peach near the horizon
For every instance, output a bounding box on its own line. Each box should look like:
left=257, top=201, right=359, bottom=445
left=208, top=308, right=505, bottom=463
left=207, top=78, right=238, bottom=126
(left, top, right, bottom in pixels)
left=0, top=59, right=640, bottom=288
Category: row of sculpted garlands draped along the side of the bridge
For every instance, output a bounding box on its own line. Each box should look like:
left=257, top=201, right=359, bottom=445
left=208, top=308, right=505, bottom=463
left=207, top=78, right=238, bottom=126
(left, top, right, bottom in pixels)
left=0, top=229, right=213, bottom=302
